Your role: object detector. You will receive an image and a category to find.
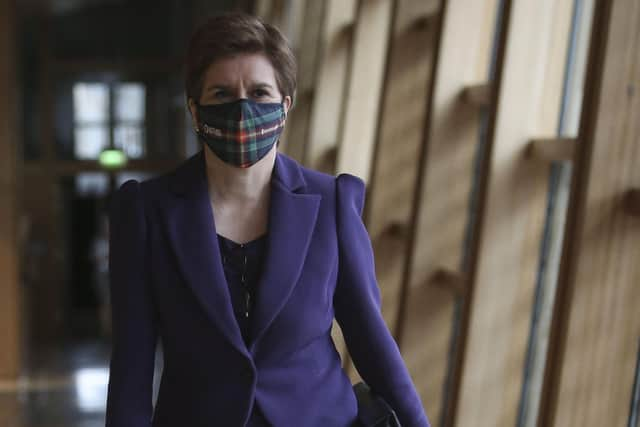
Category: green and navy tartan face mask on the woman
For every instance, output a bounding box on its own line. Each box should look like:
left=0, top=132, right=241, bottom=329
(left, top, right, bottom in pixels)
left=196, top=98, right=286, bottom=168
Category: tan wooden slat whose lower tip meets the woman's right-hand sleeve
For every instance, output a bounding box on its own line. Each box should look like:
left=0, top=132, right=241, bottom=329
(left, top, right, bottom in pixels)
left=342, top=0, right=439, bottom=381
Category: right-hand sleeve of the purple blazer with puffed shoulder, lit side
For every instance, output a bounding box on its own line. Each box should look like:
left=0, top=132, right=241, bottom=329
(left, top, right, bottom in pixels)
left=334, top=174, right=429, bottom=427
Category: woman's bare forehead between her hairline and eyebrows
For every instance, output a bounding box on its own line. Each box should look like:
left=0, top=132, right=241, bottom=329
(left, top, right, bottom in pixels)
left=203, top=53, right=276, bottom=88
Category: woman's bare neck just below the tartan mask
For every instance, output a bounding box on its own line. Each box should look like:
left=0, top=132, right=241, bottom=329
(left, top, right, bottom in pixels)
left=204, top=145, right=277, bottom=204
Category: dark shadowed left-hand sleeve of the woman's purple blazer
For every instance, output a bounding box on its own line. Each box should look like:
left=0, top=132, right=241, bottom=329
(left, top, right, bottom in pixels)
left=106, top=180, right=156, bottom=427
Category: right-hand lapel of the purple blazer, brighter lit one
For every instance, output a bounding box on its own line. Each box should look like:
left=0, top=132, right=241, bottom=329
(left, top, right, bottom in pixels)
left=251, top=153, right=322, bottom=346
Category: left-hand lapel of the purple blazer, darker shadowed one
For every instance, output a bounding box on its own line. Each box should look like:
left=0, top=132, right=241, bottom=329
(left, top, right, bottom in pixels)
left=164, top=151, right=248, bottom=354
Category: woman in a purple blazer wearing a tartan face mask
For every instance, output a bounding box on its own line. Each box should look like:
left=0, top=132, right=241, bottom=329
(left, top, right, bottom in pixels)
left=107, top=10, right=428, bottom=427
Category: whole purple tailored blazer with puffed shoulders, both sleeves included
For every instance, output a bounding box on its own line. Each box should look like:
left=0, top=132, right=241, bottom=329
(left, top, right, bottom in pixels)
left=107, top=151, right=429, bottom=427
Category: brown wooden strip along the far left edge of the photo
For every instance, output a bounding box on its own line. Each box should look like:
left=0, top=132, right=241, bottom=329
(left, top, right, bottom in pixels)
left=0, top=0, right=22, bottom=380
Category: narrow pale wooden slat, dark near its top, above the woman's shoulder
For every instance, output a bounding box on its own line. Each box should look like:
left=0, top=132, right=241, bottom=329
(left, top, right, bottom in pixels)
left=304, top=0, right=356, bottom=173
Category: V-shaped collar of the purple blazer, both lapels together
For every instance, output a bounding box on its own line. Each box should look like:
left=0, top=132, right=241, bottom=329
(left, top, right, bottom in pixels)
left=163, top=151, right=321, bottom=355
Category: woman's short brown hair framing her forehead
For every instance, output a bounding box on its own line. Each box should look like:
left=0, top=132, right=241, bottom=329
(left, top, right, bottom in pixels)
left=185, top=12, right=297, bottom=105
